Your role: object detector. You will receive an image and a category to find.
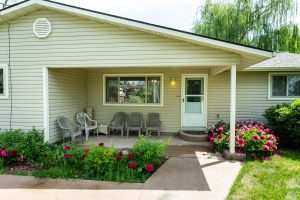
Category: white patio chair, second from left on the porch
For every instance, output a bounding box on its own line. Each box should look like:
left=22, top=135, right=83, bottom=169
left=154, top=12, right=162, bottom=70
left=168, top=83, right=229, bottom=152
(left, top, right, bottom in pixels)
left=76, top=112, right=98, bottom=141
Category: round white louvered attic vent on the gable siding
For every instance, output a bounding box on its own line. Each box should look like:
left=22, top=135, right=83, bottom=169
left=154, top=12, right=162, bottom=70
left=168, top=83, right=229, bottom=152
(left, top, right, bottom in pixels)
left=33, top=18, right=51, bottom=38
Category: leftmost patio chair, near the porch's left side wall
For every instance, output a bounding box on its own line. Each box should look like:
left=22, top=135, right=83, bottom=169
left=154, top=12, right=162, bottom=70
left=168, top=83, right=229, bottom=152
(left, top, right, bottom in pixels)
left=57, top=116, right=83, bottom=143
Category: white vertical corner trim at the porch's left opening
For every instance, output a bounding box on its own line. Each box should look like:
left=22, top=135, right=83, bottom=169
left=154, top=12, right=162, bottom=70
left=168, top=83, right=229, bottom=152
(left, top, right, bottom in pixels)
left=43, top=67, right=50, bottom=142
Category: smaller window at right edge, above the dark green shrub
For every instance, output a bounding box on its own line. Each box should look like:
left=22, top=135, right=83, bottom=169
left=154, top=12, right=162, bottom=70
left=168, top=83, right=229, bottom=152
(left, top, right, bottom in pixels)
left=270, top=73, right=300, bottom=98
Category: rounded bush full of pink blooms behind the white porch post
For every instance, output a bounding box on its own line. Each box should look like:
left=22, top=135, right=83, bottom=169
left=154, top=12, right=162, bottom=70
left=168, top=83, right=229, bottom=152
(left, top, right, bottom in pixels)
left=208, top=121, right=279, bottom=157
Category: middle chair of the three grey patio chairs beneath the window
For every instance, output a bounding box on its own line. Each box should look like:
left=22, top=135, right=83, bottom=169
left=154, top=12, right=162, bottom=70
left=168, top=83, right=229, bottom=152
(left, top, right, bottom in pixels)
left=126, top=112, right=143, bottom=138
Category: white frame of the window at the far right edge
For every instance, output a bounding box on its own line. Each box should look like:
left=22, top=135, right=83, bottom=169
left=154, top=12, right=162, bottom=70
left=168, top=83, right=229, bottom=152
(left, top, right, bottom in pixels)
left=268, top=72, right=300, bottom=100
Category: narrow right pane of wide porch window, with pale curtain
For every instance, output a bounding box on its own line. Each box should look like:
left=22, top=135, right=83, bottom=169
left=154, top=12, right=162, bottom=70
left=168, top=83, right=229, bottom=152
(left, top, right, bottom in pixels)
left=147, top=77, right=160, bottom=103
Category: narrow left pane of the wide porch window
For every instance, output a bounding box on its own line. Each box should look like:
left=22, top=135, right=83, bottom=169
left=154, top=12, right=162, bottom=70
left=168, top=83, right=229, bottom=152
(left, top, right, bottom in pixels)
left=106, top=77, right=121, bottom=103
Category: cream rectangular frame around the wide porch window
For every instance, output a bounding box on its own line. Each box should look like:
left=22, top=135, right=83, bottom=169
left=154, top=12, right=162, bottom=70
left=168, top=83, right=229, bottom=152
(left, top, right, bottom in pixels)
left=102, top=74, right=164, bottom=107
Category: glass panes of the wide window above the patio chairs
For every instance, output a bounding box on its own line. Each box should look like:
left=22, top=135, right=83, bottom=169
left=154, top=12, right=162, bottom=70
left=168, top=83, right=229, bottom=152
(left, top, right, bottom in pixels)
left=104, top=74, right=162, bottom=105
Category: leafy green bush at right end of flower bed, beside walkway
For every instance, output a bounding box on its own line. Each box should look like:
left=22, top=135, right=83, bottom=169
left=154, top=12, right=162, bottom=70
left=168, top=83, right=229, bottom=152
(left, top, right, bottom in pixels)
left=132, top=136, right=167, bottom=167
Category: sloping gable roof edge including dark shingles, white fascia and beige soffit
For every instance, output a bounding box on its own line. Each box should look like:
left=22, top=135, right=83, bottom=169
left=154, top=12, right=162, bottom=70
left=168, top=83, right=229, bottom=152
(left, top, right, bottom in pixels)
left=0, top=0, right=273, bottom=61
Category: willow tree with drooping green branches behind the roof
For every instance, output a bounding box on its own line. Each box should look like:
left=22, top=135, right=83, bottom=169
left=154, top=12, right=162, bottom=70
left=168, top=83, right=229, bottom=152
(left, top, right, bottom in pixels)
left=193, top=0, right=300, bottom=53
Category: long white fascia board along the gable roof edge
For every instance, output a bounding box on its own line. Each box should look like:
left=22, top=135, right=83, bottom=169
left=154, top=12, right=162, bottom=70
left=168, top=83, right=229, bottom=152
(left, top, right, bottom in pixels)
left=0, top=0, right=273, bottom=58
